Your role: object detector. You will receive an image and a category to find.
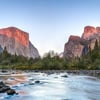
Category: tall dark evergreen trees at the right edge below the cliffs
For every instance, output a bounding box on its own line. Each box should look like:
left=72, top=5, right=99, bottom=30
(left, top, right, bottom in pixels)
left=79, top=40, right=100, bottom=70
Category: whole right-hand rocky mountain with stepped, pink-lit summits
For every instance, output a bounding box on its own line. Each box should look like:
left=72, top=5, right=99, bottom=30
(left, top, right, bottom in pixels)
left=63, top=26, right=100, bottom=58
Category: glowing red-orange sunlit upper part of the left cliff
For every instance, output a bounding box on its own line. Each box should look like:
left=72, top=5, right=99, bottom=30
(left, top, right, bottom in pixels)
left=0, top=27, right=29, bottom=47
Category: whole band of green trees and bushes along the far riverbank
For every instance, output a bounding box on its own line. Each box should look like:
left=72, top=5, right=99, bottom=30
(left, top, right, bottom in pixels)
left=0, top=41, right=100, bottom=70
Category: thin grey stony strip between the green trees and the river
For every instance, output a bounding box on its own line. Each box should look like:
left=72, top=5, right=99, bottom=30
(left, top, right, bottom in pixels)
left=0, top=69, right=100, bottom=77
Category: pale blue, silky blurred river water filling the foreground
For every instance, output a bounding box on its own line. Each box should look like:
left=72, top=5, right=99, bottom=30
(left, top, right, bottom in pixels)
left=0, top=73, right=100, bottom=100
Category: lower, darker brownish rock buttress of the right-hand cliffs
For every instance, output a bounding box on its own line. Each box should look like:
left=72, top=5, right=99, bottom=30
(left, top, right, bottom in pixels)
left=64, top=36, right=87, bottom=58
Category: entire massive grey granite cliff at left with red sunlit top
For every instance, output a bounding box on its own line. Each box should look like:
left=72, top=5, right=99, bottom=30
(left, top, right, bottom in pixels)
left=0, top=27, right=39, bottom=59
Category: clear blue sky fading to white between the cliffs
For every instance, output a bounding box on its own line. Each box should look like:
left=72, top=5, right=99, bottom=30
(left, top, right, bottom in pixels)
left=0, top=0, right=100, bottom=56
